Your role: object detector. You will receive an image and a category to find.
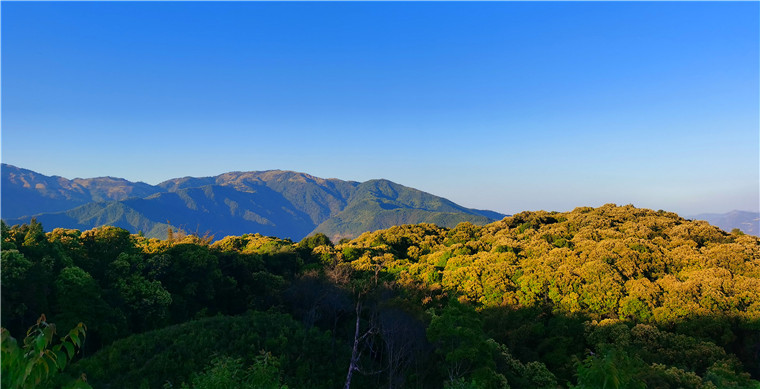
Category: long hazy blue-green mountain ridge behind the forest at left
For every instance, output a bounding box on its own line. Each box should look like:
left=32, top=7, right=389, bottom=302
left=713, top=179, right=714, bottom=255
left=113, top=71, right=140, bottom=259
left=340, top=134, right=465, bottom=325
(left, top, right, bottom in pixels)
left=2, top=164, right=506, bottom=240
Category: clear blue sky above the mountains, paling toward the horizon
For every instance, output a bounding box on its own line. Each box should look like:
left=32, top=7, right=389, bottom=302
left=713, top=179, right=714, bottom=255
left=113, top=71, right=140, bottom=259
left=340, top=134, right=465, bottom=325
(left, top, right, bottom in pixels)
left=1, top=2, right=760, bottom=215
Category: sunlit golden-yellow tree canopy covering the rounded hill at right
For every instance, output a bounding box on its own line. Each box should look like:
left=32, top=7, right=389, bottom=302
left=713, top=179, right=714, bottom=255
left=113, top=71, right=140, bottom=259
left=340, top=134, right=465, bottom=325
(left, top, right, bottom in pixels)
left=336, top=204, right=760, bottom=323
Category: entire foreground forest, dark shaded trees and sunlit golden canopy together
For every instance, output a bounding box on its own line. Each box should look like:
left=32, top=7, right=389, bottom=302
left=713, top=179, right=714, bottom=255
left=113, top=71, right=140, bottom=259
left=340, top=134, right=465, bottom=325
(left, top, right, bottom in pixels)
left=2, top=204, right=760, bottom=388
